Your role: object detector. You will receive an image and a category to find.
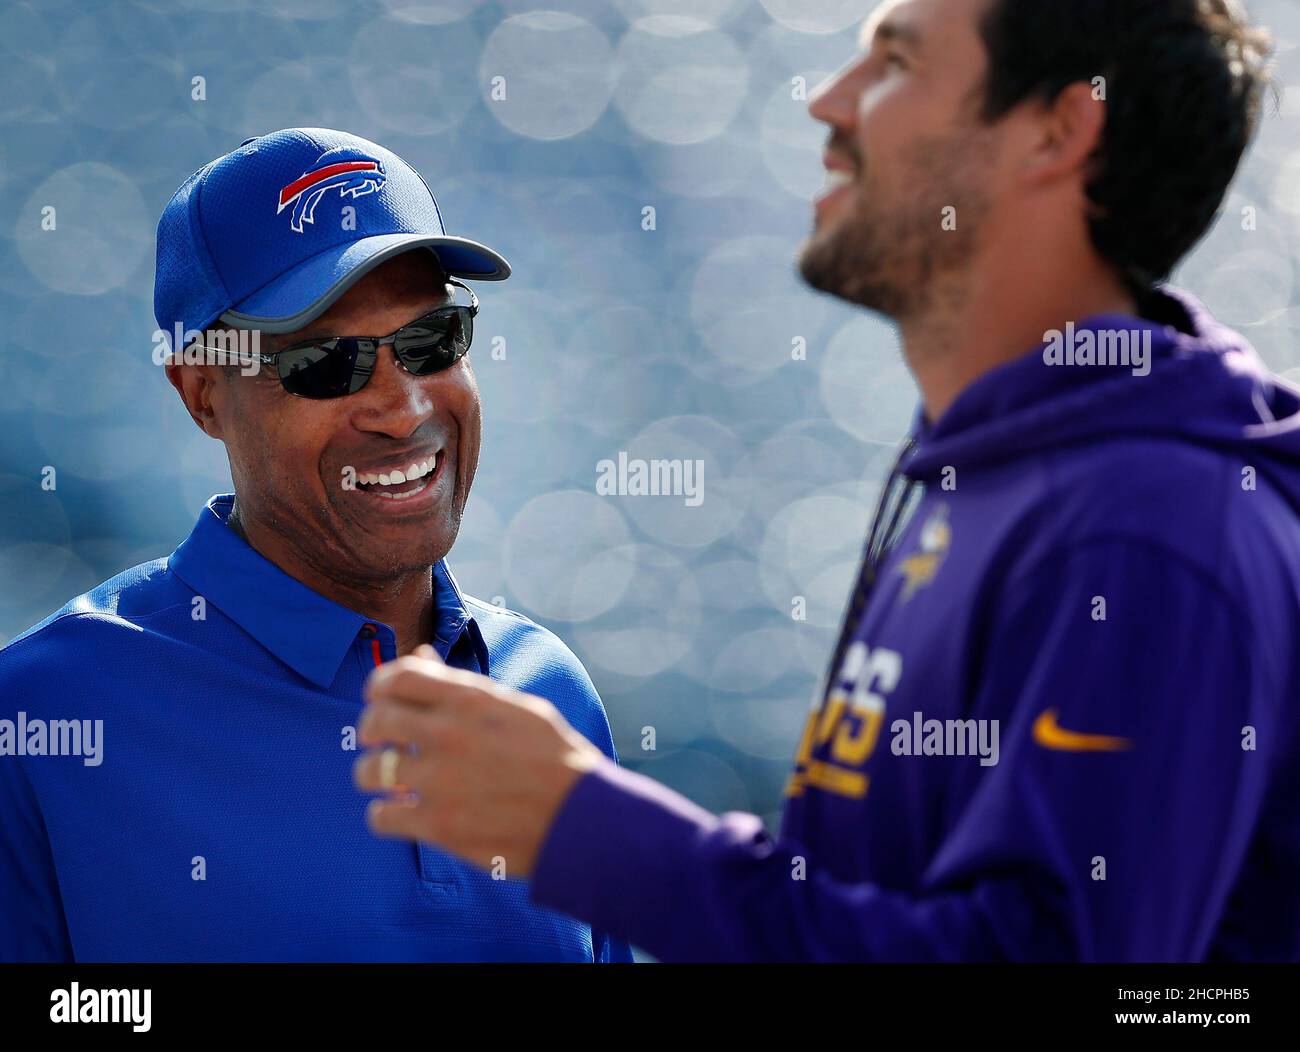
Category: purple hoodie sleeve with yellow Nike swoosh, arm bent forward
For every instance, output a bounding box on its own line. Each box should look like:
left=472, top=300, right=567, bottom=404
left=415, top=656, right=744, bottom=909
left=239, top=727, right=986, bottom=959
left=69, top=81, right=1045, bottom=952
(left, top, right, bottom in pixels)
left=533, top=538, right=1270, bottom=961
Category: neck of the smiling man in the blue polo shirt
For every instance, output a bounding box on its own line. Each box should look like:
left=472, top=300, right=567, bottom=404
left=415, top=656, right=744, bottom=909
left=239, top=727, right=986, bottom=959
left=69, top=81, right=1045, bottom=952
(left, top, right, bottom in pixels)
left=226, top=499, right=433, bottom=657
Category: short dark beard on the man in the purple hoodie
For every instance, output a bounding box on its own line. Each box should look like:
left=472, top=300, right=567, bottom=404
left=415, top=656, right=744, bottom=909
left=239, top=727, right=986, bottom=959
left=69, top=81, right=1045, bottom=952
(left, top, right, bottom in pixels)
left=798, top=129, right=993, bottom=321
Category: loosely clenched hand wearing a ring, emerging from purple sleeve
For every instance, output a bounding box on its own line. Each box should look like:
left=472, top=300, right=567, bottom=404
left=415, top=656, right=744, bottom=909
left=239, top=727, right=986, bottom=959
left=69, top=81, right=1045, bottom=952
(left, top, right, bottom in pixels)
left=354, top=646, right=608, bottom=876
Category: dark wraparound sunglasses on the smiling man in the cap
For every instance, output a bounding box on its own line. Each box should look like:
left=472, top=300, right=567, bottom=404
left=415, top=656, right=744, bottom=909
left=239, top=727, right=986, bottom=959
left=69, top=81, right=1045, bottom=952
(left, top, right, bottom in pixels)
left=245, top=280, right=478, bottom=398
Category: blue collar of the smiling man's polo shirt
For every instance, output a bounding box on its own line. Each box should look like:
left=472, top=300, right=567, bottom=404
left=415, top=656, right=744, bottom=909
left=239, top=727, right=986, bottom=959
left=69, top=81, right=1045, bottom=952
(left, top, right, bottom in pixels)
left=168, top=493, right=488, bottom=688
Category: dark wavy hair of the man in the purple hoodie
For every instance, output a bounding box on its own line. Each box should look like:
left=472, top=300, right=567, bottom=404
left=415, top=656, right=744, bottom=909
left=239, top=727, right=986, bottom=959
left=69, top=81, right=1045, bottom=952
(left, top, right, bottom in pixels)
left=980, top=0, right=1271, bottom=295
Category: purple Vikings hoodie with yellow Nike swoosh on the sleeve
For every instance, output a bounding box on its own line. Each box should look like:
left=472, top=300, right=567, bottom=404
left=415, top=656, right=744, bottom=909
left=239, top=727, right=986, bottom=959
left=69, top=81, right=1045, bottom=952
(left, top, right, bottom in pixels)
left=532, top=287, right=1300, bottom=961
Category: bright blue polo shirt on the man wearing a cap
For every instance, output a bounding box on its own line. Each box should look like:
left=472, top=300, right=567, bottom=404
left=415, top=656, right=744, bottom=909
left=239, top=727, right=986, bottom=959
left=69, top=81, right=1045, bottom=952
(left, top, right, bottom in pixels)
left=0, top=494, right=631, bottom=961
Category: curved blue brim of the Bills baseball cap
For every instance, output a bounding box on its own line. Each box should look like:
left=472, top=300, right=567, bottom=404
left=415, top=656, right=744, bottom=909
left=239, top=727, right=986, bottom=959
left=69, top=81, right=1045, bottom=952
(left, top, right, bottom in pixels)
left=221, top=234, right=510, bottom=333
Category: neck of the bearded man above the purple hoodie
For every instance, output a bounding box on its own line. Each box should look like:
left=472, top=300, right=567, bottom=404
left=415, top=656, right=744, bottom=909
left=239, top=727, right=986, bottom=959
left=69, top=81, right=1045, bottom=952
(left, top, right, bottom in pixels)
left=898, top=248, right=1138, bottom=423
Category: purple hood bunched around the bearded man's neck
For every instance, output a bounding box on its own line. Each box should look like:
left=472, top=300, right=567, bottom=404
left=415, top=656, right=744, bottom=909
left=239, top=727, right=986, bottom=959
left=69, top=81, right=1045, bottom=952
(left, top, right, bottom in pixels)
left=905, top=279, right=1300, bottom=508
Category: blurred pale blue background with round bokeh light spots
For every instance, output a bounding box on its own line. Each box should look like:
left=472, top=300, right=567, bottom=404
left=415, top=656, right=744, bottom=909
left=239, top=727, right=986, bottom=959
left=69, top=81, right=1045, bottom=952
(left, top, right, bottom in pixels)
left=0, top=0, right=1300, bottom=837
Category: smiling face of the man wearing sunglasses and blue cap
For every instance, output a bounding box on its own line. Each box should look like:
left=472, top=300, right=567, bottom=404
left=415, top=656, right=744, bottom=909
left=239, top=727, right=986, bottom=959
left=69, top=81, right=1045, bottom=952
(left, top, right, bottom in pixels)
left=197, top=251, right=481, bottom=585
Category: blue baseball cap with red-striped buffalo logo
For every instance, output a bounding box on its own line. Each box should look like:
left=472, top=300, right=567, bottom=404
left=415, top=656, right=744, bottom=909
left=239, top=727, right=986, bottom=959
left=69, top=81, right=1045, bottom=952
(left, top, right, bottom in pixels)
left=153, top=127, right=510, bottom=350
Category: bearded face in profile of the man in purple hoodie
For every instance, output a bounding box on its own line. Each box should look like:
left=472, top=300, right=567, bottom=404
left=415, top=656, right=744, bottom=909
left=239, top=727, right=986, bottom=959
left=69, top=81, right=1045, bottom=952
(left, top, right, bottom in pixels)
left=800, top=0, right=1001, bottom=319
